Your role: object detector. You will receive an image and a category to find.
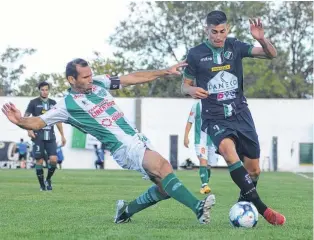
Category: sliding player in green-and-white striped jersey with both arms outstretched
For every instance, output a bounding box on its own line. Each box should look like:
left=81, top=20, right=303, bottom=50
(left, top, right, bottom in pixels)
left=2, top=59, right=215, bottom=224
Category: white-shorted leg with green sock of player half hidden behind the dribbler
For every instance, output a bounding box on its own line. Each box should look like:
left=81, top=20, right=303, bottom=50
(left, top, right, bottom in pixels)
left=195, top=144, right=211, bottom=194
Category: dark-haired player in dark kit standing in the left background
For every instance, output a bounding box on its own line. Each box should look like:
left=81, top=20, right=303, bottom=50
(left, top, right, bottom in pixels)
left=25, top=82, right=66, bottom=191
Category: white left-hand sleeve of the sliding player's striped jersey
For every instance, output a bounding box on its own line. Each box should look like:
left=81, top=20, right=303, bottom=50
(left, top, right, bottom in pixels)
left=38, top=99, right=70, bottom=126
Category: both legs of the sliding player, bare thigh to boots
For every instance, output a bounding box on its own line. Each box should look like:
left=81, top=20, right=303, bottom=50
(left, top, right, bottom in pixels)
left=115, top=142, right=215, bottom=223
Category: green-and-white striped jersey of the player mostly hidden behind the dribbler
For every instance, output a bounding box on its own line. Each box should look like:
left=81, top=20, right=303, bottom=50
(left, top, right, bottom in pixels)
left=188, top=101, right=212, bottom=146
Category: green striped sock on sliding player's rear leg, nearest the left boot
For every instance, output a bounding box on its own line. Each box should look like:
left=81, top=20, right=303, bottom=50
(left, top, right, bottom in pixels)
left=126, top=185, right=170, bottom=217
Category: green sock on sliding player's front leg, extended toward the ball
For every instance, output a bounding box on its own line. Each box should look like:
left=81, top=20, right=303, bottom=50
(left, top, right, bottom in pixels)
left=161, top=173, right=200, bottom=213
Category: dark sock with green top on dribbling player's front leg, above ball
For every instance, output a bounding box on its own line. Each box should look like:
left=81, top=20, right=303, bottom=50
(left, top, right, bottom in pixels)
left=228, top=161, right=267, bottom=215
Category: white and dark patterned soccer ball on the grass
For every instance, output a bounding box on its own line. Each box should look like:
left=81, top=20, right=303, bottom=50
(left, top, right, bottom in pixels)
left=229, top=202, right=258, bottom=228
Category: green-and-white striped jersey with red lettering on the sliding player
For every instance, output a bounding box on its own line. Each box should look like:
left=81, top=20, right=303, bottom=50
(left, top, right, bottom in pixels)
left=39, top=75, right=140, bottom=153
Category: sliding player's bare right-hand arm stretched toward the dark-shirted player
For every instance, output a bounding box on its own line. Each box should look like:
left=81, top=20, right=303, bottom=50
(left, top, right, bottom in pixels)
left=120, top=62, right=187, bottom=86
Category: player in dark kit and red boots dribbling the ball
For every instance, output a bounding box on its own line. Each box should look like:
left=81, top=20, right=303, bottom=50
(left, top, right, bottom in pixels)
left=182, top=11, right=286, bottom=225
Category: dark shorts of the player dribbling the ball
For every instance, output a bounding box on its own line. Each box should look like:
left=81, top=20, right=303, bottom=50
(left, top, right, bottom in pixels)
left=207, top=109, right=260, bottom=161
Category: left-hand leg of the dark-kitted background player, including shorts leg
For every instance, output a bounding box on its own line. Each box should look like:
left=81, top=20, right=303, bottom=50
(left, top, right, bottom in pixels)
left=33, top=139, right=46, bottom=191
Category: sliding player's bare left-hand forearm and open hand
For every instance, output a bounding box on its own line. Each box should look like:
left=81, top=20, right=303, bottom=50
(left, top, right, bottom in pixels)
left=2, top=103, right=46, bottom=130
